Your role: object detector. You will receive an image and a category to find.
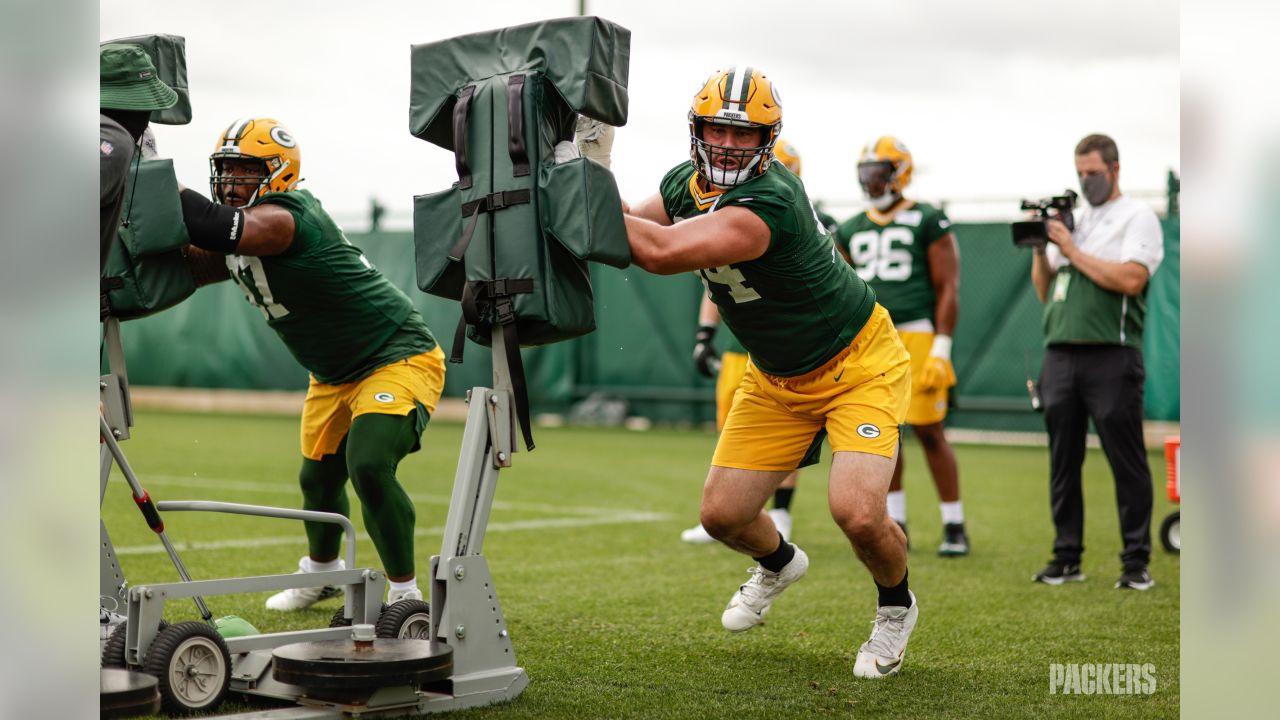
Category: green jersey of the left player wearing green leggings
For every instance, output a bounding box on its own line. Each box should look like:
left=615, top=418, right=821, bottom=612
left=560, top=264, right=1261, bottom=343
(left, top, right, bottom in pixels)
left=227, top=190, right=435, bottom=384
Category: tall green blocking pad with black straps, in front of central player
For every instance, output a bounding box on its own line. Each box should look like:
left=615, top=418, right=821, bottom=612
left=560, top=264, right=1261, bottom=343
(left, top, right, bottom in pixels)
left=410, top=18, right=631, bottom=345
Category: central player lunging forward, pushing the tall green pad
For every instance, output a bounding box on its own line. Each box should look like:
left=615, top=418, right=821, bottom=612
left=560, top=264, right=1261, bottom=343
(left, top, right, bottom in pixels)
left=626, top=67, right=919, bottom=678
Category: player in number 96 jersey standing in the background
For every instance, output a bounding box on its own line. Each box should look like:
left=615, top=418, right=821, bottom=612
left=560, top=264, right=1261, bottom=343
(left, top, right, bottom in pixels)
left=836, top=136, right=969, bottom=557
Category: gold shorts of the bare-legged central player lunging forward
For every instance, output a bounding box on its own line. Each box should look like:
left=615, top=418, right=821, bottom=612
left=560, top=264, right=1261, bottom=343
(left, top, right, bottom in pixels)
left=712, top=304, right=911, bottom=470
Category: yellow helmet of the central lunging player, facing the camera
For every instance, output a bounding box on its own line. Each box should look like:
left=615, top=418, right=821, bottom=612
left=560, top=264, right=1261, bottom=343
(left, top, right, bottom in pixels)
left=689, top=65, right=782, bottom=187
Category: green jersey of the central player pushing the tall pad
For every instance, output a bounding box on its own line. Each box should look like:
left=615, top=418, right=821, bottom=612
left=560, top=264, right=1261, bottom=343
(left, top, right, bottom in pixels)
left=660, top=161, right=876, bottom=377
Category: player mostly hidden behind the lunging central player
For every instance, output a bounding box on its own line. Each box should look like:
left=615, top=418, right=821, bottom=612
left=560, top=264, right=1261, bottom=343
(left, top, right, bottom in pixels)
left=680, top=137, right=836, bottom=544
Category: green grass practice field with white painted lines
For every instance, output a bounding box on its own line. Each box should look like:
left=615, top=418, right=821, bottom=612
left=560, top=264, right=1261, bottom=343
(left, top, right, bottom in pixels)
left=102, top=413, right=1179, bottom=719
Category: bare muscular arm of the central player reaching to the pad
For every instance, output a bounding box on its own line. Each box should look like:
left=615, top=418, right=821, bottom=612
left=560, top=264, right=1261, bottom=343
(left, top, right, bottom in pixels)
left=626, top=206, right=771, bottom=275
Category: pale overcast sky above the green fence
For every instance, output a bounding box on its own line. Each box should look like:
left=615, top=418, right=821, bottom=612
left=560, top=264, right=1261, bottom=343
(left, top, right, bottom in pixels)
left=100, top=0, right=1179, bottom=229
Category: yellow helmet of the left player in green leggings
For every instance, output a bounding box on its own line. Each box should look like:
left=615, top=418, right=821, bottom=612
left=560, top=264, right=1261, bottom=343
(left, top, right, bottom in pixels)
left=209, top=118, right=302, bottom=205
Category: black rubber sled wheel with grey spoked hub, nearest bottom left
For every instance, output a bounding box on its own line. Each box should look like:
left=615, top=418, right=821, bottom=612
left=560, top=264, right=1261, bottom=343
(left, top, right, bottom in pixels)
left=142, top=620, right=232, bottom=715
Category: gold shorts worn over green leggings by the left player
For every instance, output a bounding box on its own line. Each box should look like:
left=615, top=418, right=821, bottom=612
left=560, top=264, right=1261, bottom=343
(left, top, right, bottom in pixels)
left=302, top=346, right=444, bottom=460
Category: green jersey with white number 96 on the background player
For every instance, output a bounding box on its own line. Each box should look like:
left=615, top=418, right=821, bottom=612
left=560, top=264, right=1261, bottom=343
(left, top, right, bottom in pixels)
left=836, top=202, right=951, bottom=325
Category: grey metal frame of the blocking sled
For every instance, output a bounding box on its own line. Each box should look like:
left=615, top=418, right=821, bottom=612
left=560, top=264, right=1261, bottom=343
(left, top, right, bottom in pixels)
left=100, top=318, right=529, bottom=720
